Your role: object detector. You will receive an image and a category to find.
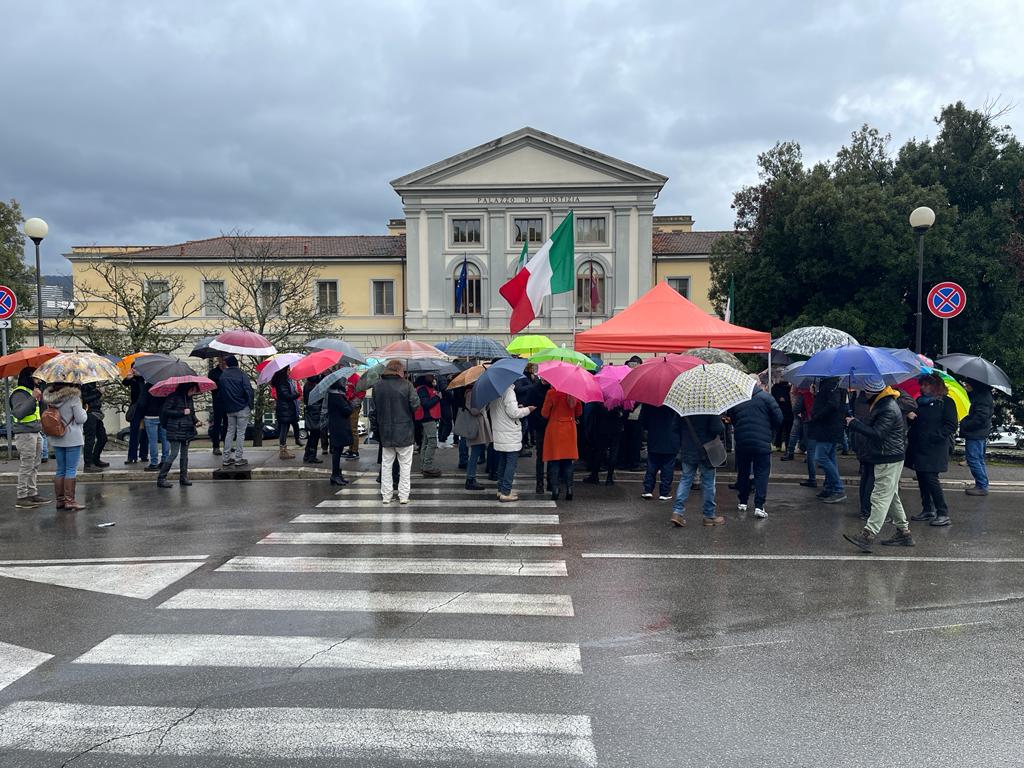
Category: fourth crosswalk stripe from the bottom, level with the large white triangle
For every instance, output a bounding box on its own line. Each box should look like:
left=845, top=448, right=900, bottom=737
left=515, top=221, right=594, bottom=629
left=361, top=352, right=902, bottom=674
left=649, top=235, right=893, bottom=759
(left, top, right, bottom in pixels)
left=217, top=557, right=567, bottom=577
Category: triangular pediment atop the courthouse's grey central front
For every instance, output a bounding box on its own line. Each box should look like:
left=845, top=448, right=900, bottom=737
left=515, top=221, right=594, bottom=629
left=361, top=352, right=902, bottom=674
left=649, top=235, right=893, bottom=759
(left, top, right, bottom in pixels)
left=391, top=128, right=668, bottom=191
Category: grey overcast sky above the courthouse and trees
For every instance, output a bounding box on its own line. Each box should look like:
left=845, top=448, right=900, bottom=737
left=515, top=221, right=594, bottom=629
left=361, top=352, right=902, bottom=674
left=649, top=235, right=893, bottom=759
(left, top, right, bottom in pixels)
left=0, top=0, right=1024, bottom=272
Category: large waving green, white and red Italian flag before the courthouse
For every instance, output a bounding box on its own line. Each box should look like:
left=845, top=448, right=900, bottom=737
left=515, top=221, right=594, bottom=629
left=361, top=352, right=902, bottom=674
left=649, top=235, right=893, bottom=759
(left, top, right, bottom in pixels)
left=499, top=211, right=575, bottom=334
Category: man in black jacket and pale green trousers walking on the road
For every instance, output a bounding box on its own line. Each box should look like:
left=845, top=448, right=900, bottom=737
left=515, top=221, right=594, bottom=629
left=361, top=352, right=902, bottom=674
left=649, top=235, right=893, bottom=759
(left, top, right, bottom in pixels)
left=843, top=376, right=913, bottom=552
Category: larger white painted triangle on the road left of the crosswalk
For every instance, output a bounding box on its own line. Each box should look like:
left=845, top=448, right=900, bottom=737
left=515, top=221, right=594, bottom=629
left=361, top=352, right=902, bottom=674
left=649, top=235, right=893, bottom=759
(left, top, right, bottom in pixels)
left=0, top=558, right=205, bottom=600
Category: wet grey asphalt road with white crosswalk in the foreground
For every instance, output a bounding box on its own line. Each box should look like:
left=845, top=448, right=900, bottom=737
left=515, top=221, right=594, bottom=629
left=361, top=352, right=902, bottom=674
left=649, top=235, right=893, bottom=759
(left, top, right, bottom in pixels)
left=0, top=462, right=1024, bottom=768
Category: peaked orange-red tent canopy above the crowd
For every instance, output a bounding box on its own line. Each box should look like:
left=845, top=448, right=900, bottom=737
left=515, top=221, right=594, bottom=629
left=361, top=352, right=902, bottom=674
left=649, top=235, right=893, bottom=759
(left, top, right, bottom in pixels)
left=575, top=283, right=771, bottom=352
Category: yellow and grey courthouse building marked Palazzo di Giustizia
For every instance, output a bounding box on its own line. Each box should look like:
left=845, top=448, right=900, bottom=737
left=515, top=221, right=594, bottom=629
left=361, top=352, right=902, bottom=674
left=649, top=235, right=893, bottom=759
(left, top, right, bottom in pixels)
left=66, top=128, right=725, bottom=348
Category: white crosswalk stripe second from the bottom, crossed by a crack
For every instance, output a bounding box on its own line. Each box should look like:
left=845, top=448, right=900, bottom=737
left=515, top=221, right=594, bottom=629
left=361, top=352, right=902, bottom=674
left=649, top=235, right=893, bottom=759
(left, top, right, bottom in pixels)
left=74, top=635, right=583, bottom=675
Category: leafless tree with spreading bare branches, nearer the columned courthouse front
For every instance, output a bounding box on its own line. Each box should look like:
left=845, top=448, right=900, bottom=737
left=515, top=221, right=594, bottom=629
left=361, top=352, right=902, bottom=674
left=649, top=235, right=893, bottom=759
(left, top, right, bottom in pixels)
left=203, top=231, right=342, bottom=445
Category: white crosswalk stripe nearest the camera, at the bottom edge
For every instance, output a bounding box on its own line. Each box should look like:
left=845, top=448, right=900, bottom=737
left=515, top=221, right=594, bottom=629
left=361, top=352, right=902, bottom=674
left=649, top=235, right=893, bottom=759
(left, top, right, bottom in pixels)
left=0, top=701, right=597, bottom=766
